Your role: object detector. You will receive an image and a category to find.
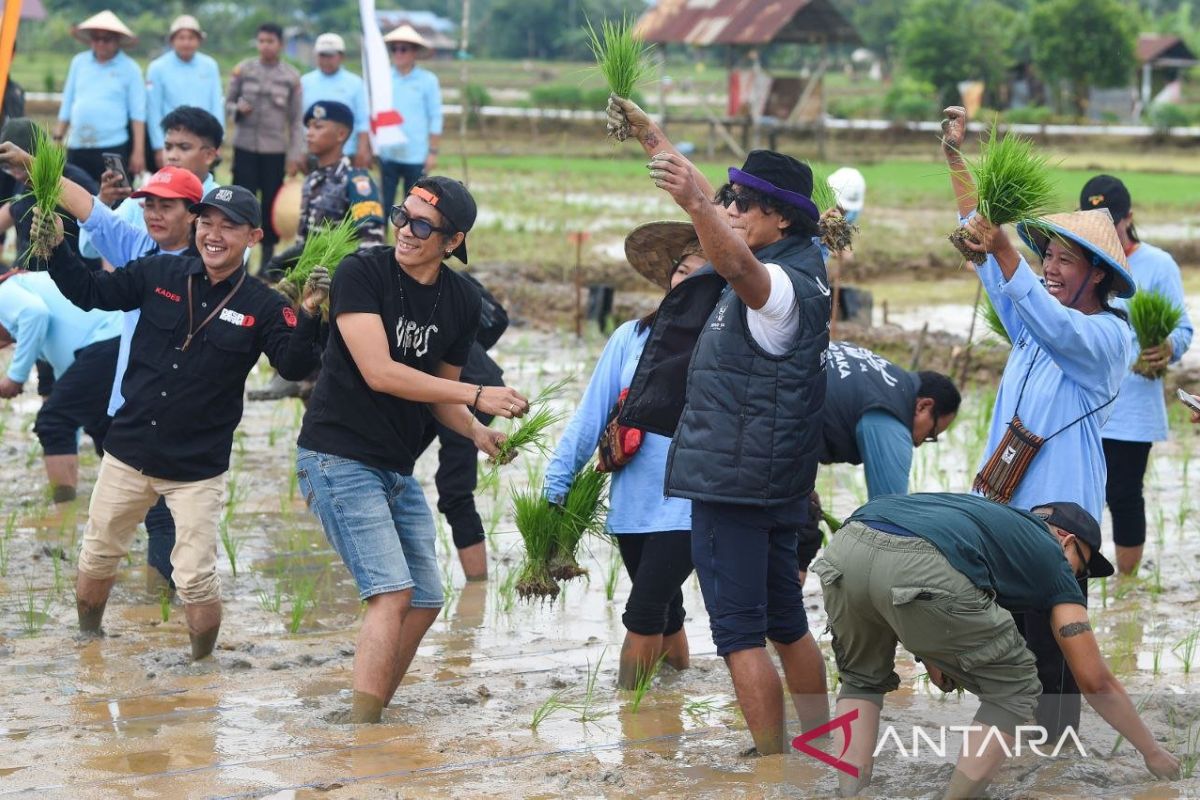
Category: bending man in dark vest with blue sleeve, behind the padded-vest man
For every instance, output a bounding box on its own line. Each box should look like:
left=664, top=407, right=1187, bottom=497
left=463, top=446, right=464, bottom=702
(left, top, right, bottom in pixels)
left=798, top=342, right=962, bottom=584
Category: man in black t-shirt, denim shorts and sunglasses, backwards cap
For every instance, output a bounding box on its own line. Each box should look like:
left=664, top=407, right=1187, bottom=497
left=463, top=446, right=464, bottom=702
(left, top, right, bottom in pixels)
left=296, top=176, right=529, bottom=722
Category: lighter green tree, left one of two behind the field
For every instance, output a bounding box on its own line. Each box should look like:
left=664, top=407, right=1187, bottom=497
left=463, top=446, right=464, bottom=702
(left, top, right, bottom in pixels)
left=896, top=0, right=1018, bottom=106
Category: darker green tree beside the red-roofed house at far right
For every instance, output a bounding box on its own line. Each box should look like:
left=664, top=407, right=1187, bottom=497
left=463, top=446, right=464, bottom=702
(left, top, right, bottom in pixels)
left=1030, top=0, right=1138, bottom=116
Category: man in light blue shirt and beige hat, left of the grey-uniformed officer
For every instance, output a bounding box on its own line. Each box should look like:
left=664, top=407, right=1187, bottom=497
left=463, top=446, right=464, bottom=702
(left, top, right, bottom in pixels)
left=146, top=14, right=224, bottom=168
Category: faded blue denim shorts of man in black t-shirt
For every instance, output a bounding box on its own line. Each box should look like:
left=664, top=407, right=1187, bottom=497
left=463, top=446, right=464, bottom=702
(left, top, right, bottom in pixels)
left=296, top=447, right=443, bottom=608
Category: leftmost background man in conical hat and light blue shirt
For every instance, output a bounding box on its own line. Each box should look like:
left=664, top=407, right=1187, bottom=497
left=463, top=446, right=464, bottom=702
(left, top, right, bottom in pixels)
left=54, top=11, right=146, bottom=181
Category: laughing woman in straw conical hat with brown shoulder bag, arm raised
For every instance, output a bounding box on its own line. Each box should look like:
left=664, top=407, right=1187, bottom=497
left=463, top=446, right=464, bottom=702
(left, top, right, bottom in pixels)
left=942, top=107, right=1134, bottom=739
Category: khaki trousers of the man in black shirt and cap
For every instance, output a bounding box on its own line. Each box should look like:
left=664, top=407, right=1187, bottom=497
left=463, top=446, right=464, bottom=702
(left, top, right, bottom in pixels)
left=79, top=455, right=226, bottom=603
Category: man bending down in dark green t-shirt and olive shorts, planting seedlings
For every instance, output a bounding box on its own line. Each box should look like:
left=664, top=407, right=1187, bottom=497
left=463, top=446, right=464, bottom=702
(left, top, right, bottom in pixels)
left=812, top=494, right=1180, bottom=798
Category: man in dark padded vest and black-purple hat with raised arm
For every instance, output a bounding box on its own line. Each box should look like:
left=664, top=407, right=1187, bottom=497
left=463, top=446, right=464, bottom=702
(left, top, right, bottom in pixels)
left=623, top=148, right=830, bottom=756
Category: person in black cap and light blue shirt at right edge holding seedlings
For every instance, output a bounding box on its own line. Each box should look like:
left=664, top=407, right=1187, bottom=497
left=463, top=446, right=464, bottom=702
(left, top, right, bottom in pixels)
left=1079, top=175, right=1192, bottom=575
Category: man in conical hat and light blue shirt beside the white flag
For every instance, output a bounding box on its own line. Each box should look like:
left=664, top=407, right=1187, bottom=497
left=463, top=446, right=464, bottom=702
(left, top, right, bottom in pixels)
left=379, top=25, right=442, bottom=216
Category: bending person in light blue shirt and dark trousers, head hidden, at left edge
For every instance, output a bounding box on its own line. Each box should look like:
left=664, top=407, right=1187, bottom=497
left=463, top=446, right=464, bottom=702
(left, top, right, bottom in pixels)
left=0, top=272, right=121, bottom=503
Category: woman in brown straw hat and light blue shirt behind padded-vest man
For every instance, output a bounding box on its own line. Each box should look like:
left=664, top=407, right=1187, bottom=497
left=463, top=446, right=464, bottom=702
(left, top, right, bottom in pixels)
left=545, top=222, right=706, bottom=688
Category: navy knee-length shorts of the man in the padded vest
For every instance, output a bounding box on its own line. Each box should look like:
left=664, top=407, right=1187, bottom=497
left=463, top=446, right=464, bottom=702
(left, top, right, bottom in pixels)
left=691, top=497, right=809, bottom=656
